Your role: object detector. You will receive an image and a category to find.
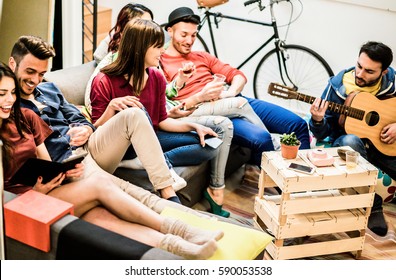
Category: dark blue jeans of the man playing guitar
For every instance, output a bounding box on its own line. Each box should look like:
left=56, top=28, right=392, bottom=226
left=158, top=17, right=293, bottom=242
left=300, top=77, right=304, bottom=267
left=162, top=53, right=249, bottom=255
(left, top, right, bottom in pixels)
left=332, top=134, right=396, bottom=180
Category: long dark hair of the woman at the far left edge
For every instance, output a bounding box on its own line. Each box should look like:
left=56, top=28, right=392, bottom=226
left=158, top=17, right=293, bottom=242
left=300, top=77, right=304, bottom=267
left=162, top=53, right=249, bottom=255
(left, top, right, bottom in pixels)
left=0, top=62, right=27, bottom=171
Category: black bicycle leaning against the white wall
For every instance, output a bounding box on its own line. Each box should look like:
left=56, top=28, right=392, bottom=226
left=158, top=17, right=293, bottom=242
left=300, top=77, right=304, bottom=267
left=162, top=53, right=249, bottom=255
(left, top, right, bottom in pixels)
left=176, top=0, right=334, bottom=115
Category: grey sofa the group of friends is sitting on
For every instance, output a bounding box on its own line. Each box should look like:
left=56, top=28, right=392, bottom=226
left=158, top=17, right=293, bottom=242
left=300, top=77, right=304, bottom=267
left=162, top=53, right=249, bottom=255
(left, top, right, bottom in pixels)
left=44, top=61, right=250, bottom=207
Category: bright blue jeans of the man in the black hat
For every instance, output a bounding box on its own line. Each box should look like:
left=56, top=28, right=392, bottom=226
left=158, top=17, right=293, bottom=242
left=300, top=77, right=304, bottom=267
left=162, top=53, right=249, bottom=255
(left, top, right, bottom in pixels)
left=231, top=96, right=310, bottom=166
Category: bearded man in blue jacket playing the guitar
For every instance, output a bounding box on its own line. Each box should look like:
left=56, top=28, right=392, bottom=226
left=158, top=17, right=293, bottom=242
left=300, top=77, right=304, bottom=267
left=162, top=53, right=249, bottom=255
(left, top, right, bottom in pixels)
left=309, top=42, right=396, bottom=236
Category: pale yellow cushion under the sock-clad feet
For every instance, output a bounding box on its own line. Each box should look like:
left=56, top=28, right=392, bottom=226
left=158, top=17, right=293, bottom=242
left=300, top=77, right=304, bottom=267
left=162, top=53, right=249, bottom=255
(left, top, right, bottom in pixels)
left=161, top=207, right=272, bottom=260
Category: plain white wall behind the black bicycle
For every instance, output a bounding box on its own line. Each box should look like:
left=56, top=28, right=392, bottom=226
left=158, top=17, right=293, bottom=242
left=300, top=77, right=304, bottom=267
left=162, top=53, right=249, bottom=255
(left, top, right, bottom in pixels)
left=99, top=0, right=396, bottom=98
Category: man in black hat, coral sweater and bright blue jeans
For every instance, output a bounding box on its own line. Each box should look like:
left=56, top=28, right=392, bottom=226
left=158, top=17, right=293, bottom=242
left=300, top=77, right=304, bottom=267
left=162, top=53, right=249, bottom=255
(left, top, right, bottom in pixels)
left=161, top=7, right=310, bottom=171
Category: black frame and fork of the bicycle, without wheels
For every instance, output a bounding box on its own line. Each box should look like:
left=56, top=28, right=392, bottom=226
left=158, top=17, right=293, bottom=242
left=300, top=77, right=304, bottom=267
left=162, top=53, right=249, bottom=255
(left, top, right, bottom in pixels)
left=198, top=1, right=296, bottom=87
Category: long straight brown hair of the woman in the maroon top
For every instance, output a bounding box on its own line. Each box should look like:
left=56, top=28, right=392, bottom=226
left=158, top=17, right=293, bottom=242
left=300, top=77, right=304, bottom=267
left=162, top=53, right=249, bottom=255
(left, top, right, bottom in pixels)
left=101, top=19, right=165, bottom=95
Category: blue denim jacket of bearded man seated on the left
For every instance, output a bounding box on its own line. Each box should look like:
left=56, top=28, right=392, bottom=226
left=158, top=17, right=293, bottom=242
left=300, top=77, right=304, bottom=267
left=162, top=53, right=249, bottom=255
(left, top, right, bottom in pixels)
left=21, top=83, right=95, bottom=161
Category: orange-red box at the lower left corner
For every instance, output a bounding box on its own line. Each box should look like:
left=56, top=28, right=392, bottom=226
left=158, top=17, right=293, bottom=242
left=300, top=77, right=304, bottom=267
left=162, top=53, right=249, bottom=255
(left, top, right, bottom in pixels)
left=4, top=190, right=74, bottom=252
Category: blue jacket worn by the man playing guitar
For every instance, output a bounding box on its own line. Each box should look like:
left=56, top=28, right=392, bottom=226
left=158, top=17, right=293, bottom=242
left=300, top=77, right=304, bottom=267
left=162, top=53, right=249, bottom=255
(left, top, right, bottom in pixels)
left=309, top=67, right=396, bottom=142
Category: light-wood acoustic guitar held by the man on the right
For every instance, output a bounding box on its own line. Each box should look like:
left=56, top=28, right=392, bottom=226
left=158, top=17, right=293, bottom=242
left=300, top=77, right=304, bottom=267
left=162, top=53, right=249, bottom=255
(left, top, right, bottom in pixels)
left=268, top=83, right=396, bottom=156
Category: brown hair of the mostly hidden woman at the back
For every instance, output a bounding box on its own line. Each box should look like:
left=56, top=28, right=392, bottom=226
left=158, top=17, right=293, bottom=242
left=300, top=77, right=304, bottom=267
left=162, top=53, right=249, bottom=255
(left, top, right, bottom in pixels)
left=107, top=3, right=154, bottom=52
